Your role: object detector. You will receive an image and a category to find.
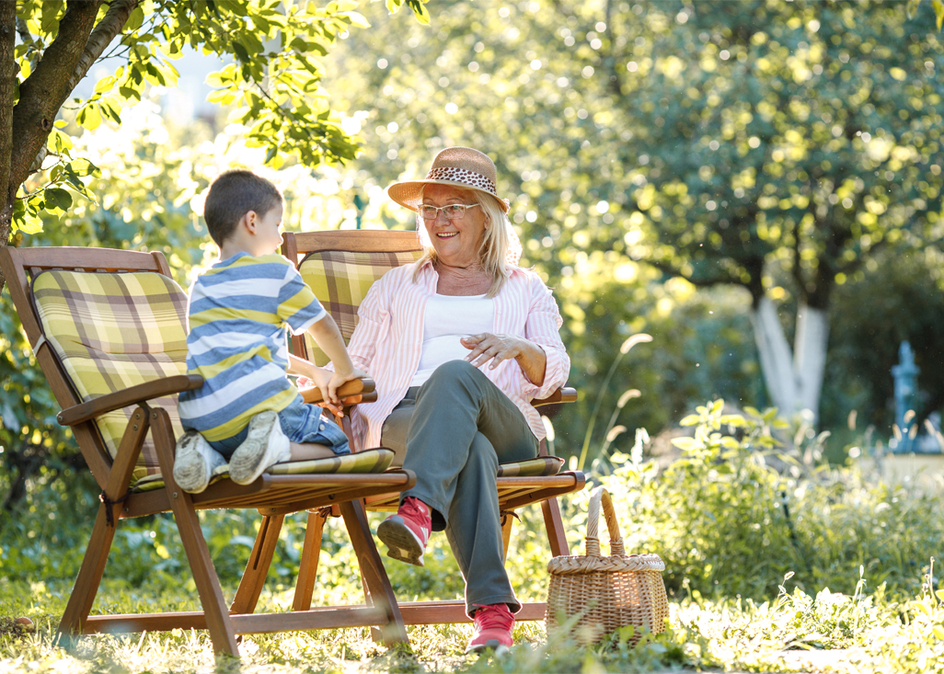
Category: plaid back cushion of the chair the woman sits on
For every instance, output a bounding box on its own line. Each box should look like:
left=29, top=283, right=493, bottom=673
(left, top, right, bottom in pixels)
left=298, top=250, right=423, bottom=365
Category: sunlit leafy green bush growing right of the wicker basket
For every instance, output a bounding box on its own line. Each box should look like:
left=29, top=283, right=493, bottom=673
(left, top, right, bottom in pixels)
left=601, top=400, right=944, bottom=598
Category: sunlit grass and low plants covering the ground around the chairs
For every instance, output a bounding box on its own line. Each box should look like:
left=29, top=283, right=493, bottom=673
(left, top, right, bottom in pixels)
left=0, top=403, right=944, bottom=674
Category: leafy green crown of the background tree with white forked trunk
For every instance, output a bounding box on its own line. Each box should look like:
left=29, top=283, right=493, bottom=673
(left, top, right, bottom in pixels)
left=614, top=2, right=944, bottom=307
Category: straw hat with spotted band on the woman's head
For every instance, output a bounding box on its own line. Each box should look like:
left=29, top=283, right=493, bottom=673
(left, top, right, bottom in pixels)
left=387, top=147, right=508, bottom=213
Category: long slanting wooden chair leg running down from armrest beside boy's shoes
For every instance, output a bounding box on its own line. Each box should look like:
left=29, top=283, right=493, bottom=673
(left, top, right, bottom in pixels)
left=151, top=408, right=239, bottom=657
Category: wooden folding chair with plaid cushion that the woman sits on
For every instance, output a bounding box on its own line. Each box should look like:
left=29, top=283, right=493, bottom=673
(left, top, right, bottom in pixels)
left=282, top=230, right=586, bottom=625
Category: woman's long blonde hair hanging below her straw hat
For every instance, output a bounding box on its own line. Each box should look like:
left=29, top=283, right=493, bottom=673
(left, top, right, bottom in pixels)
left=413, top=185, right=520, bottom=297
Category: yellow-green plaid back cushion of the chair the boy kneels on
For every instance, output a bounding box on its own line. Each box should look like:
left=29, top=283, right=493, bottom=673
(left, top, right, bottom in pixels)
left=32, top=270, right=187, bottom=483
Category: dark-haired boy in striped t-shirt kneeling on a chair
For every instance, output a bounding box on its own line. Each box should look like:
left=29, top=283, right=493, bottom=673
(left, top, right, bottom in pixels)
left=174, top=170, right=362, bottom=493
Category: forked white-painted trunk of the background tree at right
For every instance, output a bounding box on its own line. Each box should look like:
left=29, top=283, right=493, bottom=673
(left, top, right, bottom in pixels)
left=751, top=297, right=829, bottom=423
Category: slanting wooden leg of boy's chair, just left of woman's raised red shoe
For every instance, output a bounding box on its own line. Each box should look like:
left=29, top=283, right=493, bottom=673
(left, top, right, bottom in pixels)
left=341, top=501, right=410, bottom=646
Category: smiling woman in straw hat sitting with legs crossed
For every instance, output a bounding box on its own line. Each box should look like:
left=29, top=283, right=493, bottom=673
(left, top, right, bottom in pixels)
left=349, top=147, right=570, bottom=651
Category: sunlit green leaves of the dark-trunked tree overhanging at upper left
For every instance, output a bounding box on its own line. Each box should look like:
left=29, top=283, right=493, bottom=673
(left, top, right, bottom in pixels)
left=13, top=0, right=429, bottom=233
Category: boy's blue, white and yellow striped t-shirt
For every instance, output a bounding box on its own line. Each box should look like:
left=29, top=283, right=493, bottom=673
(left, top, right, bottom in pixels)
left=180, top=253, right=327, bottom=442
